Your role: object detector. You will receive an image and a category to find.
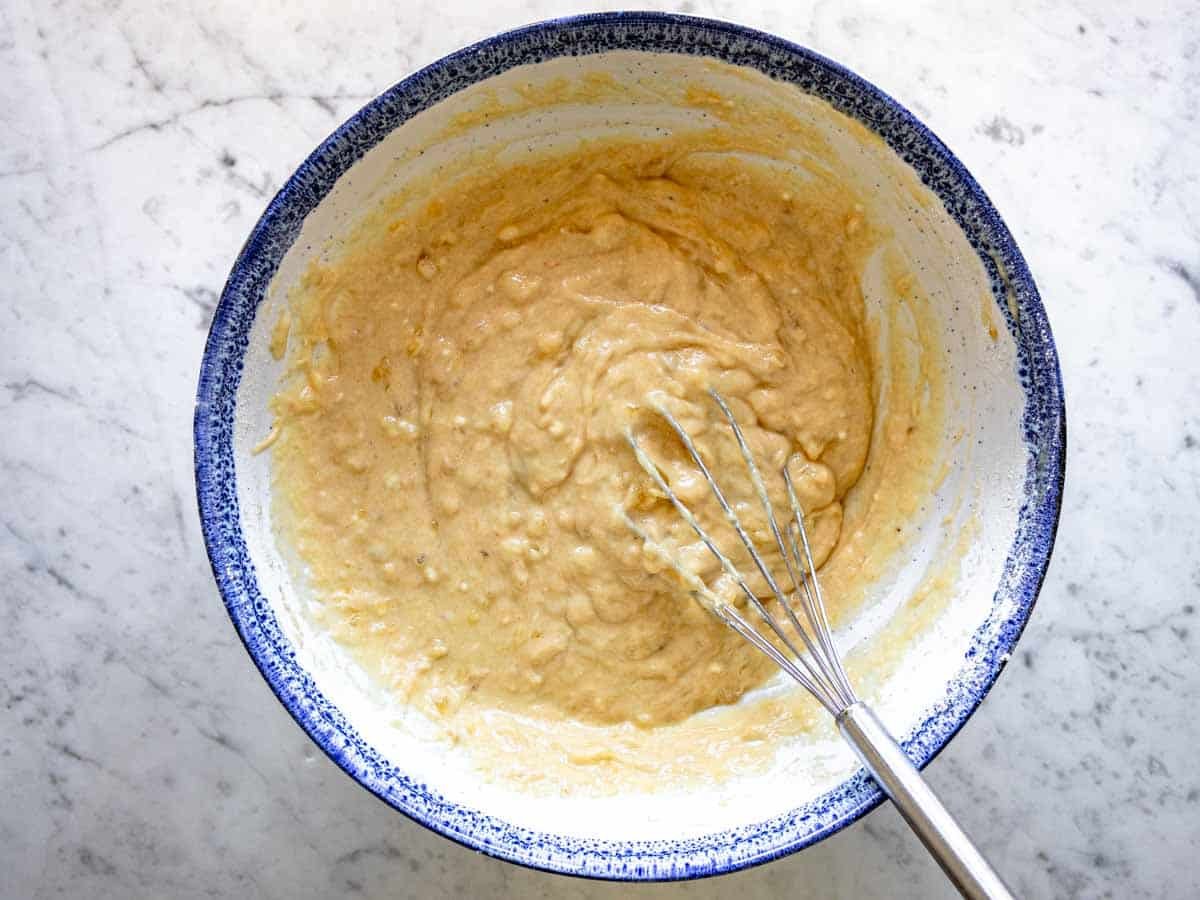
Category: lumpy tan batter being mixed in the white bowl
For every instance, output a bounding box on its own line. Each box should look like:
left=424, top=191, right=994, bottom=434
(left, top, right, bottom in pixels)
left=272, top=118, right=940, bottom=776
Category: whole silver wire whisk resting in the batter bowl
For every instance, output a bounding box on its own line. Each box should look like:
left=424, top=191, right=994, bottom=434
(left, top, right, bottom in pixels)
left=622, top=390, right=1012, bottom=900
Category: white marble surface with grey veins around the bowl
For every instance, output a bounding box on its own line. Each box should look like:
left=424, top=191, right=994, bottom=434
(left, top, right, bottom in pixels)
left=0, top=0, right=1200, bottom=900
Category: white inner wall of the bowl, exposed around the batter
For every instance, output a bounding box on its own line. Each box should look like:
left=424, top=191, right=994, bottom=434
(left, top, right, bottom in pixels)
left=235, top=52, right=1027, bottom=839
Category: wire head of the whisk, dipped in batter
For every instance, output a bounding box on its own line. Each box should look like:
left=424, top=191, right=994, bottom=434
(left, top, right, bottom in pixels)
left=622, top=390, right=857, bottom=716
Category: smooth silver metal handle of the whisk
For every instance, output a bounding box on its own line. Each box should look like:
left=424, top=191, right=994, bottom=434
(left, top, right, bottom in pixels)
left=838, top=702, right=1013, bottom=900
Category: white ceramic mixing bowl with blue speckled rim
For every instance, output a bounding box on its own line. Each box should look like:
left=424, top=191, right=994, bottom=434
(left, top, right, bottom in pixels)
left=194, top=13, right=1066, bottom=880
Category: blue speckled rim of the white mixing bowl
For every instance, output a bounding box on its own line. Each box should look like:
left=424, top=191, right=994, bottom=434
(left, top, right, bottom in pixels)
left=194, top=12, right=1066, bottom=881
